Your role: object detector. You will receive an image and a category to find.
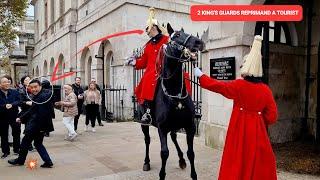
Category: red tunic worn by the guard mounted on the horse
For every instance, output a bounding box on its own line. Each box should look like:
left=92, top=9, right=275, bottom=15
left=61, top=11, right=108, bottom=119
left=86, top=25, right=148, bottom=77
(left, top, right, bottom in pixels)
left=135, top=35, right=192, bottom=104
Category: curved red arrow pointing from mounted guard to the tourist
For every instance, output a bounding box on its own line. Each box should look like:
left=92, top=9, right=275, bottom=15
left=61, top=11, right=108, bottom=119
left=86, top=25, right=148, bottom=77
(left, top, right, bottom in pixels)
left=51, top=30, right=144, bottom=82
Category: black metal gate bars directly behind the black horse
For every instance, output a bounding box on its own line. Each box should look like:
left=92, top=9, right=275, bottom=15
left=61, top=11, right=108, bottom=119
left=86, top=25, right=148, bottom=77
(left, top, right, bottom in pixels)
left=132, top=49, right=202, bottom=135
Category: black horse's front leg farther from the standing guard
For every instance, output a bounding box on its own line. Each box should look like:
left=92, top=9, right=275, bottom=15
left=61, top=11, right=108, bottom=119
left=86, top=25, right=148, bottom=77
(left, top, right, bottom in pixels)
left=158, top=128, right=169, bottom=180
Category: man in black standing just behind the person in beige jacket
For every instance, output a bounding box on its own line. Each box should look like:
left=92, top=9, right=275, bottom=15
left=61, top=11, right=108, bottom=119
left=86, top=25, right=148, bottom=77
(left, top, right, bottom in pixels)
left=72, top=77, right=84, bottom=131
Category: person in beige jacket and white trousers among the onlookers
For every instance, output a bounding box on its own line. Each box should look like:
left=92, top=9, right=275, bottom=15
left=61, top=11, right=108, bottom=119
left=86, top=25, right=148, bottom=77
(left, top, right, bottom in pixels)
left=55, top=84, right=78, bottom=141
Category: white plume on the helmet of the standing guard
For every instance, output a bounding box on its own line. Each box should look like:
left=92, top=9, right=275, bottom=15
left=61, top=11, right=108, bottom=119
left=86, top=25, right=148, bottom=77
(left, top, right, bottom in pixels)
left=240, top=35, right=263, bottom=77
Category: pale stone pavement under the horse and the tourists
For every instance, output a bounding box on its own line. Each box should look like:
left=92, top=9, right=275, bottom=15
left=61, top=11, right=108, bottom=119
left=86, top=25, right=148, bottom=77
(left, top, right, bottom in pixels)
left=0, top=113, right=320, bottom=180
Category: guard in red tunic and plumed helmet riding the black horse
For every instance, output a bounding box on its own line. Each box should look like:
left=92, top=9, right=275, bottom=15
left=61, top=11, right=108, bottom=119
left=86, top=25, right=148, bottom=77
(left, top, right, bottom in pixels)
left=126, top=8, right=191, bottom=125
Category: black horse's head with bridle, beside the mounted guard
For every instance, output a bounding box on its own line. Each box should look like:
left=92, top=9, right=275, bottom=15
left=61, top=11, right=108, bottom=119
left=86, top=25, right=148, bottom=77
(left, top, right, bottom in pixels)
left=167, top=23, right=204, bottom=60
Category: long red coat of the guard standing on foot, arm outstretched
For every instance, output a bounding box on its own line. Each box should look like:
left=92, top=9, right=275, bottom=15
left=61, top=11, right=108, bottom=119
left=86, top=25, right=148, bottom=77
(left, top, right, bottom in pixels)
left=200, top=75, right=277, bottom=180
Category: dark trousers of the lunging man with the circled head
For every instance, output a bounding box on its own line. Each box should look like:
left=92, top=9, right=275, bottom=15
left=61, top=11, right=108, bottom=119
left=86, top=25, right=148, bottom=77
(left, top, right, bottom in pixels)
left=18, top=132, right=52, bottom=163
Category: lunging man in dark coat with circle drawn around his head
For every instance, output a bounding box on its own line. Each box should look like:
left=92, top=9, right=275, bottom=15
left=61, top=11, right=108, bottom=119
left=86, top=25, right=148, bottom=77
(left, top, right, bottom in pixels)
left=8, top=79, right=54, bottom=168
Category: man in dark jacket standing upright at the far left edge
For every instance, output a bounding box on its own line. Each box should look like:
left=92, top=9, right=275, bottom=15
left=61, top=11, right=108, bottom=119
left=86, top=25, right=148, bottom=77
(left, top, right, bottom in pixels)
left=0, top=77, right=21, bottom=158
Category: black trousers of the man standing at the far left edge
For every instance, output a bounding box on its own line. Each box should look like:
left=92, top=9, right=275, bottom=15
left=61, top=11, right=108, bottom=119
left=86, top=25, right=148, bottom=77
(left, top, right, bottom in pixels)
left=0, top=119, right=21, bottom=154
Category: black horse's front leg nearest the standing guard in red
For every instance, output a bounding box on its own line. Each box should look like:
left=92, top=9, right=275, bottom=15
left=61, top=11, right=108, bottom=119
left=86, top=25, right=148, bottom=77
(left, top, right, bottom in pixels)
left=186, top=125, right=198, bottom=180
